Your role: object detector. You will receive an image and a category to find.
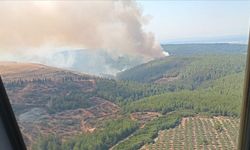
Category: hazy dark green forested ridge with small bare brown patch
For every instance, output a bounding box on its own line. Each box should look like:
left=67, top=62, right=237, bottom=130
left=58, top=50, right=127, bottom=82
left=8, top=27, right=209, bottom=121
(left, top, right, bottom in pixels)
left=117, top=54, right=246, bottom=89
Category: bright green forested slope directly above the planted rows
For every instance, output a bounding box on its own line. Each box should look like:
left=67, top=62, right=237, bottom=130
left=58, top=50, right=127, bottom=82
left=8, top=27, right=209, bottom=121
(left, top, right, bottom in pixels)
left=124, top=73, right=243, bottom=116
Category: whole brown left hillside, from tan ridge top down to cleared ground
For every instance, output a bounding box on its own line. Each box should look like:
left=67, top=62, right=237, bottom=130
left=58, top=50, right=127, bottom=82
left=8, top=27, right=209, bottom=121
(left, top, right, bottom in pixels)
left=0, top=62, right=120, bottom=148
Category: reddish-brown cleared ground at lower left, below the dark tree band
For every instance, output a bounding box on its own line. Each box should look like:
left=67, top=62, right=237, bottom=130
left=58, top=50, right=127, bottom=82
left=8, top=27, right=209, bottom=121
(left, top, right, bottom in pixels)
left=19, top=97, right=119, bottom=146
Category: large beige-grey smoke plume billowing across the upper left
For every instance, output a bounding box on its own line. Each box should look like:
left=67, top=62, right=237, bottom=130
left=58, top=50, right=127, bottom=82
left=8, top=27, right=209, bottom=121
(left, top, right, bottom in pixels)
left=0, top=1, right=162, bottom=58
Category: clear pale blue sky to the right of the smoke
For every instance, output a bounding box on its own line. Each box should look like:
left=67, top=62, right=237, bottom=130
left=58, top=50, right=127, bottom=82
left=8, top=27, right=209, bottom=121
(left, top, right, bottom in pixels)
left=138, top=0, right=250, bottom=42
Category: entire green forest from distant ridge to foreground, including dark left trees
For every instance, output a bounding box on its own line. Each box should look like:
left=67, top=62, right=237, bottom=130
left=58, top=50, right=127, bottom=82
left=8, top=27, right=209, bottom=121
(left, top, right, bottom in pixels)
left=6, top=44, right=246, bottom=150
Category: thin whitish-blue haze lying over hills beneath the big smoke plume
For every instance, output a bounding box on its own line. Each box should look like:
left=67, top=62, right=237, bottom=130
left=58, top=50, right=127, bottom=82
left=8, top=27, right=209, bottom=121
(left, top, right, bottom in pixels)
left=2, top=49, right=146, bottom=76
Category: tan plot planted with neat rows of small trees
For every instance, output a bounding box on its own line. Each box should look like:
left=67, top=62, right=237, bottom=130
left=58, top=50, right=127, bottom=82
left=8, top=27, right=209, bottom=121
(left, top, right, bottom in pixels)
left=141, top=116, right=239, bottom=150
